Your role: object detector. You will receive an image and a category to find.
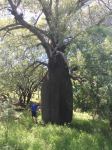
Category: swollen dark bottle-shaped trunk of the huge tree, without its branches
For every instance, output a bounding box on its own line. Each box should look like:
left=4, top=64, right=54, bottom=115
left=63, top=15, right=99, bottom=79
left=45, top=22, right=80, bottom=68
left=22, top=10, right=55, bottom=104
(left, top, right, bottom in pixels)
left=41, top=53, right=73, bottom=124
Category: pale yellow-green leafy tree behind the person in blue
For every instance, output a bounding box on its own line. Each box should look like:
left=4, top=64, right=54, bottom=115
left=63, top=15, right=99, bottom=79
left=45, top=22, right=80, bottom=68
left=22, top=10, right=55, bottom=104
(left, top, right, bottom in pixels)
left=0, top=25, right=46, bottom=106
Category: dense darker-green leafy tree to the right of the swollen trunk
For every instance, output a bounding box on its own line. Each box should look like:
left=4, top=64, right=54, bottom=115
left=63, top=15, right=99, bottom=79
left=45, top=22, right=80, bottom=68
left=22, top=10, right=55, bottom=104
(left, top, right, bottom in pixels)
left=70, top=26, right=112, bottom=125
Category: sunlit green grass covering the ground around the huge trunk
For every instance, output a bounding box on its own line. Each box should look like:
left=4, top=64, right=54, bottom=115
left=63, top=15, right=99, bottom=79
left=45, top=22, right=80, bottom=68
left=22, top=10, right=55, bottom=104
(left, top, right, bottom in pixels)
left=0, top=112, right=112, bottom=150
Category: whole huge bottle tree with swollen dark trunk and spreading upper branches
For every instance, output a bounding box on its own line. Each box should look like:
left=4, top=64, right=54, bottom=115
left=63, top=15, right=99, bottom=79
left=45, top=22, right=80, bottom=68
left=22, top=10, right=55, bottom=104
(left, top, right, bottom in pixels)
left=1, top=0, right=110, bottom=124
